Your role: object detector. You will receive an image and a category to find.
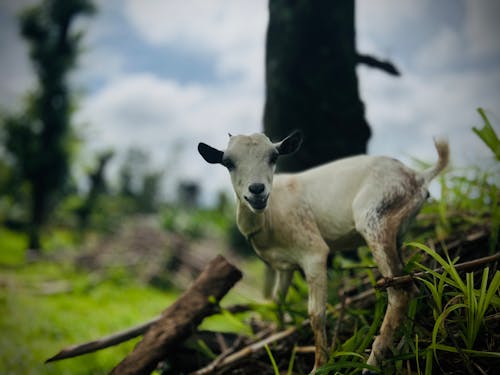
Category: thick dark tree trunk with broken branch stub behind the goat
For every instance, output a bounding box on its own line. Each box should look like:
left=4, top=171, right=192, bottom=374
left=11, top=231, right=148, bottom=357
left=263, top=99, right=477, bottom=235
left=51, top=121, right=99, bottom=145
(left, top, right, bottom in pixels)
left=264, top=0, right=399, bottom=171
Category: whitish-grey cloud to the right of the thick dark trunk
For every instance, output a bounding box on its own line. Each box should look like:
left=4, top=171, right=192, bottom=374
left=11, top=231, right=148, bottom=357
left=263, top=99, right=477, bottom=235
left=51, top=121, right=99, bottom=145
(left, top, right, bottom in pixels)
left=357, top=0, right=500, bottom=173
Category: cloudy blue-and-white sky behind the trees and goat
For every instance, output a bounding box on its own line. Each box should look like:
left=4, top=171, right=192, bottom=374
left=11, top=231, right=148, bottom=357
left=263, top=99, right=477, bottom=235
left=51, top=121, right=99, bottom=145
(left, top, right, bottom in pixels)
left=0, top=0, right=500, bottom=206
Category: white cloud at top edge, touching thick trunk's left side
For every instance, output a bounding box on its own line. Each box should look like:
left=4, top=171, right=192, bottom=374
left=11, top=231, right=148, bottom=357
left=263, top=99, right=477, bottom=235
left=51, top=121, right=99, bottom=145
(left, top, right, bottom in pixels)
left=125, top=0, right=267, bottom=87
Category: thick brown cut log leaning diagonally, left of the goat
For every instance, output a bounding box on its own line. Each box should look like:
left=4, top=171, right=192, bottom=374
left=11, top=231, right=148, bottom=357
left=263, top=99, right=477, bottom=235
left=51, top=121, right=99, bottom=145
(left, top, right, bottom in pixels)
left=111, top=256, right=242, bottom=375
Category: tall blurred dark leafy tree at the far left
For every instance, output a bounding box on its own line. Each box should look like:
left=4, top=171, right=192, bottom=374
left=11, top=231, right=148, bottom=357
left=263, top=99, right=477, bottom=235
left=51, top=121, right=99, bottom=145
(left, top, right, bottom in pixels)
left=4, top=0, right=94, bottom=251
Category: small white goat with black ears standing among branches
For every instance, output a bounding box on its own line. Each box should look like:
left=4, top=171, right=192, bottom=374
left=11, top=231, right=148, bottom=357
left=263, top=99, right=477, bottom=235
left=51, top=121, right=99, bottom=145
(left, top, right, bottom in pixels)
left=198, top=132, right=449, bottom=372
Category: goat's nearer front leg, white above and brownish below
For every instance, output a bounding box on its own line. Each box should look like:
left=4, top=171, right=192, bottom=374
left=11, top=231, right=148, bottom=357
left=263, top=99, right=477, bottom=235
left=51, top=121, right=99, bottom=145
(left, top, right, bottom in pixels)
left=303, top=250, right=328, bottom=374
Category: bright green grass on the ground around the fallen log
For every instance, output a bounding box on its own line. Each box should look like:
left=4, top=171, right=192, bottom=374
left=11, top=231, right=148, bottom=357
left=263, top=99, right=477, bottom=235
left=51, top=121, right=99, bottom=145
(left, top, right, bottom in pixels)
left=0, top=228, right=262, bottom=375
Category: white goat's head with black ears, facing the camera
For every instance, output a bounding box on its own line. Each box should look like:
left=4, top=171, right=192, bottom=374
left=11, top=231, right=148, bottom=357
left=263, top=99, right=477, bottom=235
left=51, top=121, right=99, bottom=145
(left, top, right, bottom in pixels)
left=198, top=131, right=302, bottom=213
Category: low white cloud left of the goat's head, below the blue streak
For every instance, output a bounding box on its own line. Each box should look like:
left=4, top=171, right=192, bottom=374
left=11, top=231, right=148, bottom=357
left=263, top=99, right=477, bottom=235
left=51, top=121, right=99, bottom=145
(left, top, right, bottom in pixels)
left=78, top=74, right=262, bottom=201
